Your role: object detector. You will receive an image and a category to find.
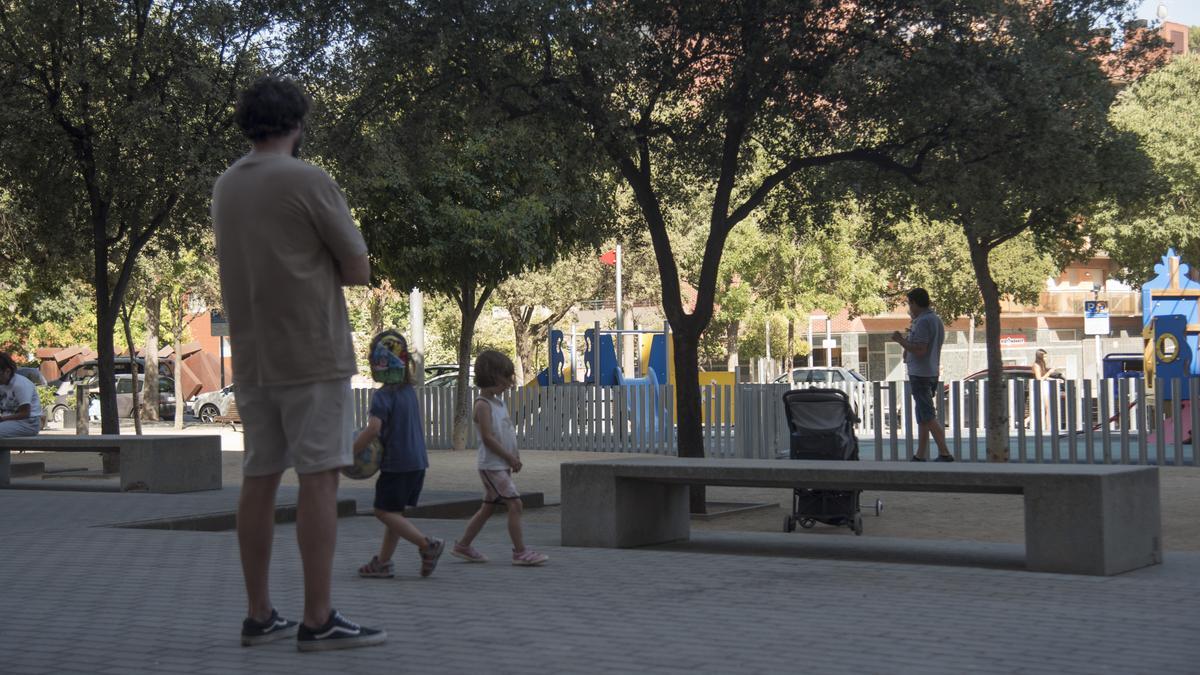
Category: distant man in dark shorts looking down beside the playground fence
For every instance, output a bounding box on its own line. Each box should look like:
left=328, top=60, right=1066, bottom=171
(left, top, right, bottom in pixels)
left=892, top=288, right=954, bottom=461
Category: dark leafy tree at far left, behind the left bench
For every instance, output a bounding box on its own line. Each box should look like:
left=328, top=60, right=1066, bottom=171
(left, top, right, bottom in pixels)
left=0, top=0, right=270, bottom=434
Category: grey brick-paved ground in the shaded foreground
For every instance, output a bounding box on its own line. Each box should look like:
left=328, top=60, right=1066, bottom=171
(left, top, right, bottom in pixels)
left=7, top=425, right=1200, bottom=675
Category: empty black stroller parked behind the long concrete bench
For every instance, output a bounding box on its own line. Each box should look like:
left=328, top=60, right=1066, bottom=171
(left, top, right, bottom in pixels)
left=784, top=389, right=883, bottom=534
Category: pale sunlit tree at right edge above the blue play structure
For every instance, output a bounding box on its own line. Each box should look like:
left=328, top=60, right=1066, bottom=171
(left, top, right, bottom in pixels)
left=1098, top=53, right=1200, bottom=283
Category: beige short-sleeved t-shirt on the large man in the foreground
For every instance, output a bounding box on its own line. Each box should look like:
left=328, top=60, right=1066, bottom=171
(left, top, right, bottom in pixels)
left=212, top=153, right=367, bottom=386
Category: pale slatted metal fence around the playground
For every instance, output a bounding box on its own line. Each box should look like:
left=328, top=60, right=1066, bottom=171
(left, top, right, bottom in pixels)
left=355, top=378, right=1200, bottom=466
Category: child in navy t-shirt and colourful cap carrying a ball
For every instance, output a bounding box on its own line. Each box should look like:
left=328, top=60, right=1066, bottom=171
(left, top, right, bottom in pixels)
left=354, top=330, right=445, bottom=579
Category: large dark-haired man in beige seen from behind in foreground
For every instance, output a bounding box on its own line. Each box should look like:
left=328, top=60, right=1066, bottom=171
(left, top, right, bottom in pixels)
left=212, top=77, right=388, bottom=651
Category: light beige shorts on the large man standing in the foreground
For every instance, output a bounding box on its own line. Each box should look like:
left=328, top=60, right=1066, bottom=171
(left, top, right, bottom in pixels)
left=234, top=377, right=354, bottom=476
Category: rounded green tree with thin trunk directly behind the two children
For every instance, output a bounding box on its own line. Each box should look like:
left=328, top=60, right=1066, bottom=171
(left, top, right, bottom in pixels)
left=328, top=22, right=608, bottom=449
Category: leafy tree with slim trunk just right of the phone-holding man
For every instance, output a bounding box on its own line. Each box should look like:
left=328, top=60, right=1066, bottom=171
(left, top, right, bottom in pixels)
left=897, top=0, right=1146, bottom=461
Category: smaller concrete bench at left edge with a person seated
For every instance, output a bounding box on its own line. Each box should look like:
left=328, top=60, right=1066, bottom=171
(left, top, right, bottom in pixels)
left=0, top=435, right=221, bottom=492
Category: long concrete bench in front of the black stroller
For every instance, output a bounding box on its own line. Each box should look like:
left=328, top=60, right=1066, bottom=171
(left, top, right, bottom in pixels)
left=562, top=458, right=1162, bottom=575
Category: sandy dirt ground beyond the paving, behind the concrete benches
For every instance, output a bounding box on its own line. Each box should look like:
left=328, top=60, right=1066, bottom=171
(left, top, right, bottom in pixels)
left=12, top=426, right=1200, bottom=551
